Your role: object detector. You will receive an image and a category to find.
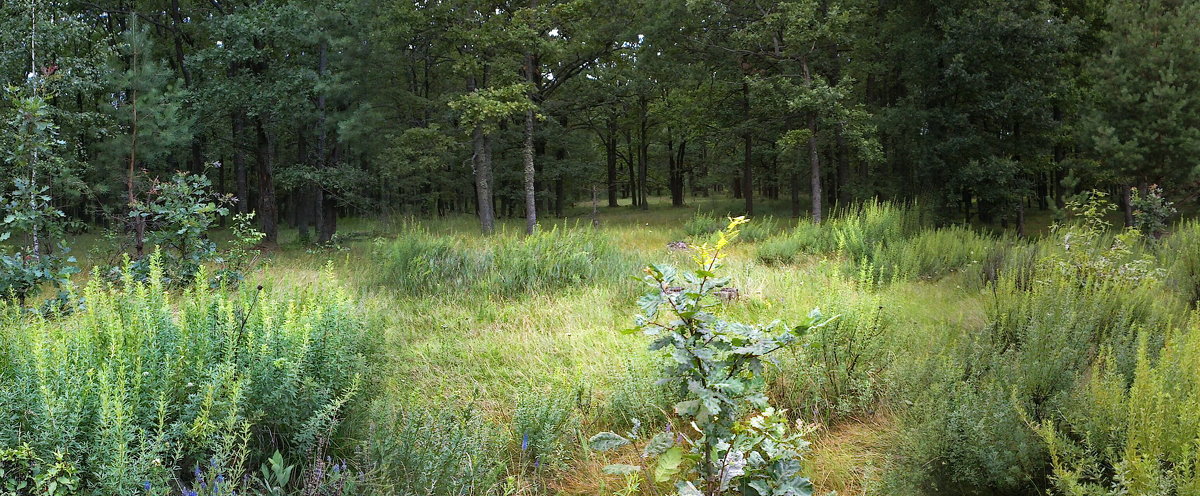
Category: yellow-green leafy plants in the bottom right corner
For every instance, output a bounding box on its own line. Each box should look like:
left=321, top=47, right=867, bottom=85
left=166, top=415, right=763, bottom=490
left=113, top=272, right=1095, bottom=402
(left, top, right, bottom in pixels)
left=1037, top=324, right=1200, bottom=495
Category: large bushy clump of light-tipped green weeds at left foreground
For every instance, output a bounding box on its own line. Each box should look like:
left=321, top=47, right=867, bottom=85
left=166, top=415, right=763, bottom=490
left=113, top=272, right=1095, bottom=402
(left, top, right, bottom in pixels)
left=0, top=257, right=367, bottom=494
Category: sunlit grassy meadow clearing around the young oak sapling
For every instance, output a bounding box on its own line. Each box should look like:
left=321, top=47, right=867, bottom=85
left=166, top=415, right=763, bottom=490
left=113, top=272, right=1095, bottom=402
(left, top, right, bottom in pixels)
left=0, top=195, right=1200, bottom=495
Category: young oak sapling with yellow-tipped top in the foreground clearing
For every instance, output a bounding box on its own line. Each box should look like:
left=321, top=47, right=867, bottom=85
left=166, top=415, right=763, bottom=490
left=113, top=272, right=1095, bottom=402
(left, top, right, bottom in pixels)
left=589, top=217, right=828, bottom=496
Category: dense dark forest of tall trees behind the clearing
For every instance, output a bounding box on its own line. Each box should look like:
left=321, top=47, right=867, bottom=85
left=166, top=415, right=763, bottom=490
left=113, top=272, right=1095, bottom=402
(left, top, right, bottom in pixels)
left=0, top=0, right=1200, bottom=245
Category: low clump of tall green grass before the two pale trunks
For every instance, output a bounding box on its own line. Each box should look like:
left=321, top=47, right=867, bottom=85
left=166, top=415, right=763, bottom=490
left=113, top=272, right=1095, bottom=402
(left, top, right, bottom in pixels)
left=376, top=228, right=631, bottom=297
